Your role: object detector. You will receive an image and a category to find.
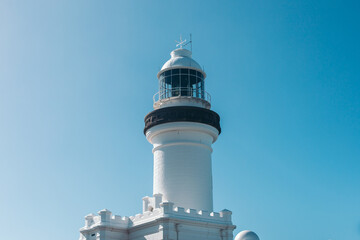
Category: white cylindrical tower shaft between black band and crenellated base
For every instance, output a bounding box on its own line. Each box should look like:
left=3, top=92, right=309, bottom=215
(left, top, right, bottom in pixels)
left=146, top=122, right=219, bottom=212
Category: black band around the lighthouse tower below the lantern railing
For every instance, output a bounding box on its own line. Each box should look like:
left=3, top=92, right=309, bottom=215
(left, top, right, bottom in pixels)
left=144, top=106, right=221, bottom=134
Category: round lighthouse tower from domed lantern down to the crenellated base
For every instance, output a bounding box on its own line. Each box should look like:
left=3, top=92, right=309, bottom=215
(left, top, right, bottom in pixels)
left=144, top=48, right=221, bottom=212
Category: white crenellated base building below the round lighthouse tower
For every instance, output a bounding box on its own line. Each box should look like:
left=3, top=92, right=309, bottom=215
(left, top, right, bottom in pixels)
left=80, top=200, right=235, bottom=240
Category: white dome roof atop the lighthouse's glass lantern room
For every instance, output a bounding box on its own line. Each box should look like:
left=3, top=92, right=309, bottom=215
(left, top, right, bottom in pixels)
left=158, top=48, right=206, bottom=77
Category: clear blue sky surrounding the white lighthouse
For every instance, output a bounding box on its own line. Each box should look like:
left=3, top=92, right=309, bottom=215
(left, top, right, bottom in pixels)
left=0, top=0, right=360, bottom=240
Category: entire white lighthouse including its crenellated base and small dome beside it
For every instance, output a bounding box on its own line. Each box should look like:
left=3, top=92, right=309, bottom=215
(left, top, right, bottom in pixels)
left=80, top=42, right=258, bottom=240
